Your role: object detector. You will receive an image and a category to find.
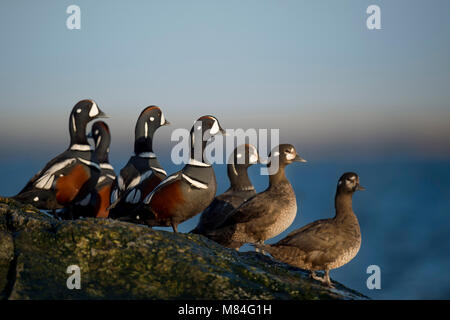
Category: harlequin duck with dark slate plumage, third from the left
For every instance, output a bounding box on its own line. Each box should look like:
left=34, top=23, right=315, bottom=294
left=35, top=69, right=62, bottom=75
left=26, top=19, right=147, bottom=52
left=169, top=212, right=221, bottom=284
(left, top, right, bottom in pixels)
left=110, top=106, right=170, bottom=218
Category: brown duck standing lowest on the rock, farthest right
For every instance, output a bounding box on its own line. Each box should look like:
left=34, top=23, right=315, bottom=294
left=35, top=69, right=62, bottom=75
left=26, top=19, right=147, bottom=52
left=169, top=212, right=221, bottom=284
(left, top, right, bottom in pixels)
left=256, top=172, right=364, bottom=286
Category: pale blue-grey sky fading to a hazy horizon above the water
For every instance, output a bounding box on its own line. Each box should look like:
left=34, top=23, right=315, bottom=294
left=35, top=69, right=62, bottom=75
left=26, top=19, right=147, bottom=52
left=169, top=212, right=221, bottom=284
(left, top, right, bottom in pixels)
left=0, top=0, right=450, bottom=159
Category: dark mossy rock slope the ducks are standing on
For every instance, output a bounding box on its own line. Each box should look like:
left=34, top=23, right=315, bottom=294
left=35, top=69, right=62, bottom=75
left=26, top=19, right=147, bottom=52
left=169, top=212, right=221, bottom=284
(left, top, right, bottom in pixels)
left=0, top=198, right=367, bottom=299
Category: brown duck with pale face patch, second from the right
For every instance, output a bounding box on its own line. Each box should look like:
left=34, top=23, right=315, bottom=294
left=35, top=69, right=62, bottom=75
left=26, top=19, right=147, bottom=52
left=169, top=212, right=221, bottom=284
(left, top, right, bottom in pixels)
left=206, top=144, right=306, bottom=250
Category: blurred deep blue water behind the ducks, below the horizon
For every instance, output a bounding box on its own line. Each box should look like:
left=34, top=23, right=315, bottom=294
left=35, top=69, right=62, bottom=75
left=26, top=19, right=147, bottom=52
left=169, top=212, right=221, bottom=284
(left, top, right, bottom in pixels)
left=0, top=154, right=450, bottom=299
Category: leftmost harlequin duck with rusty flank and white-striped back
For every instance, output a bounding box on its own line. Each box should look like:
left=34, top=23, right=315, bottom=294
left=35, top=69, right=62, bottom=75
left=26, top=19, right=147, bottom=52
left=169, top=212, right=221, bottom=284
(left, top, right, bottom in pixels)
left=13, top=100, right=106, bottom=210
